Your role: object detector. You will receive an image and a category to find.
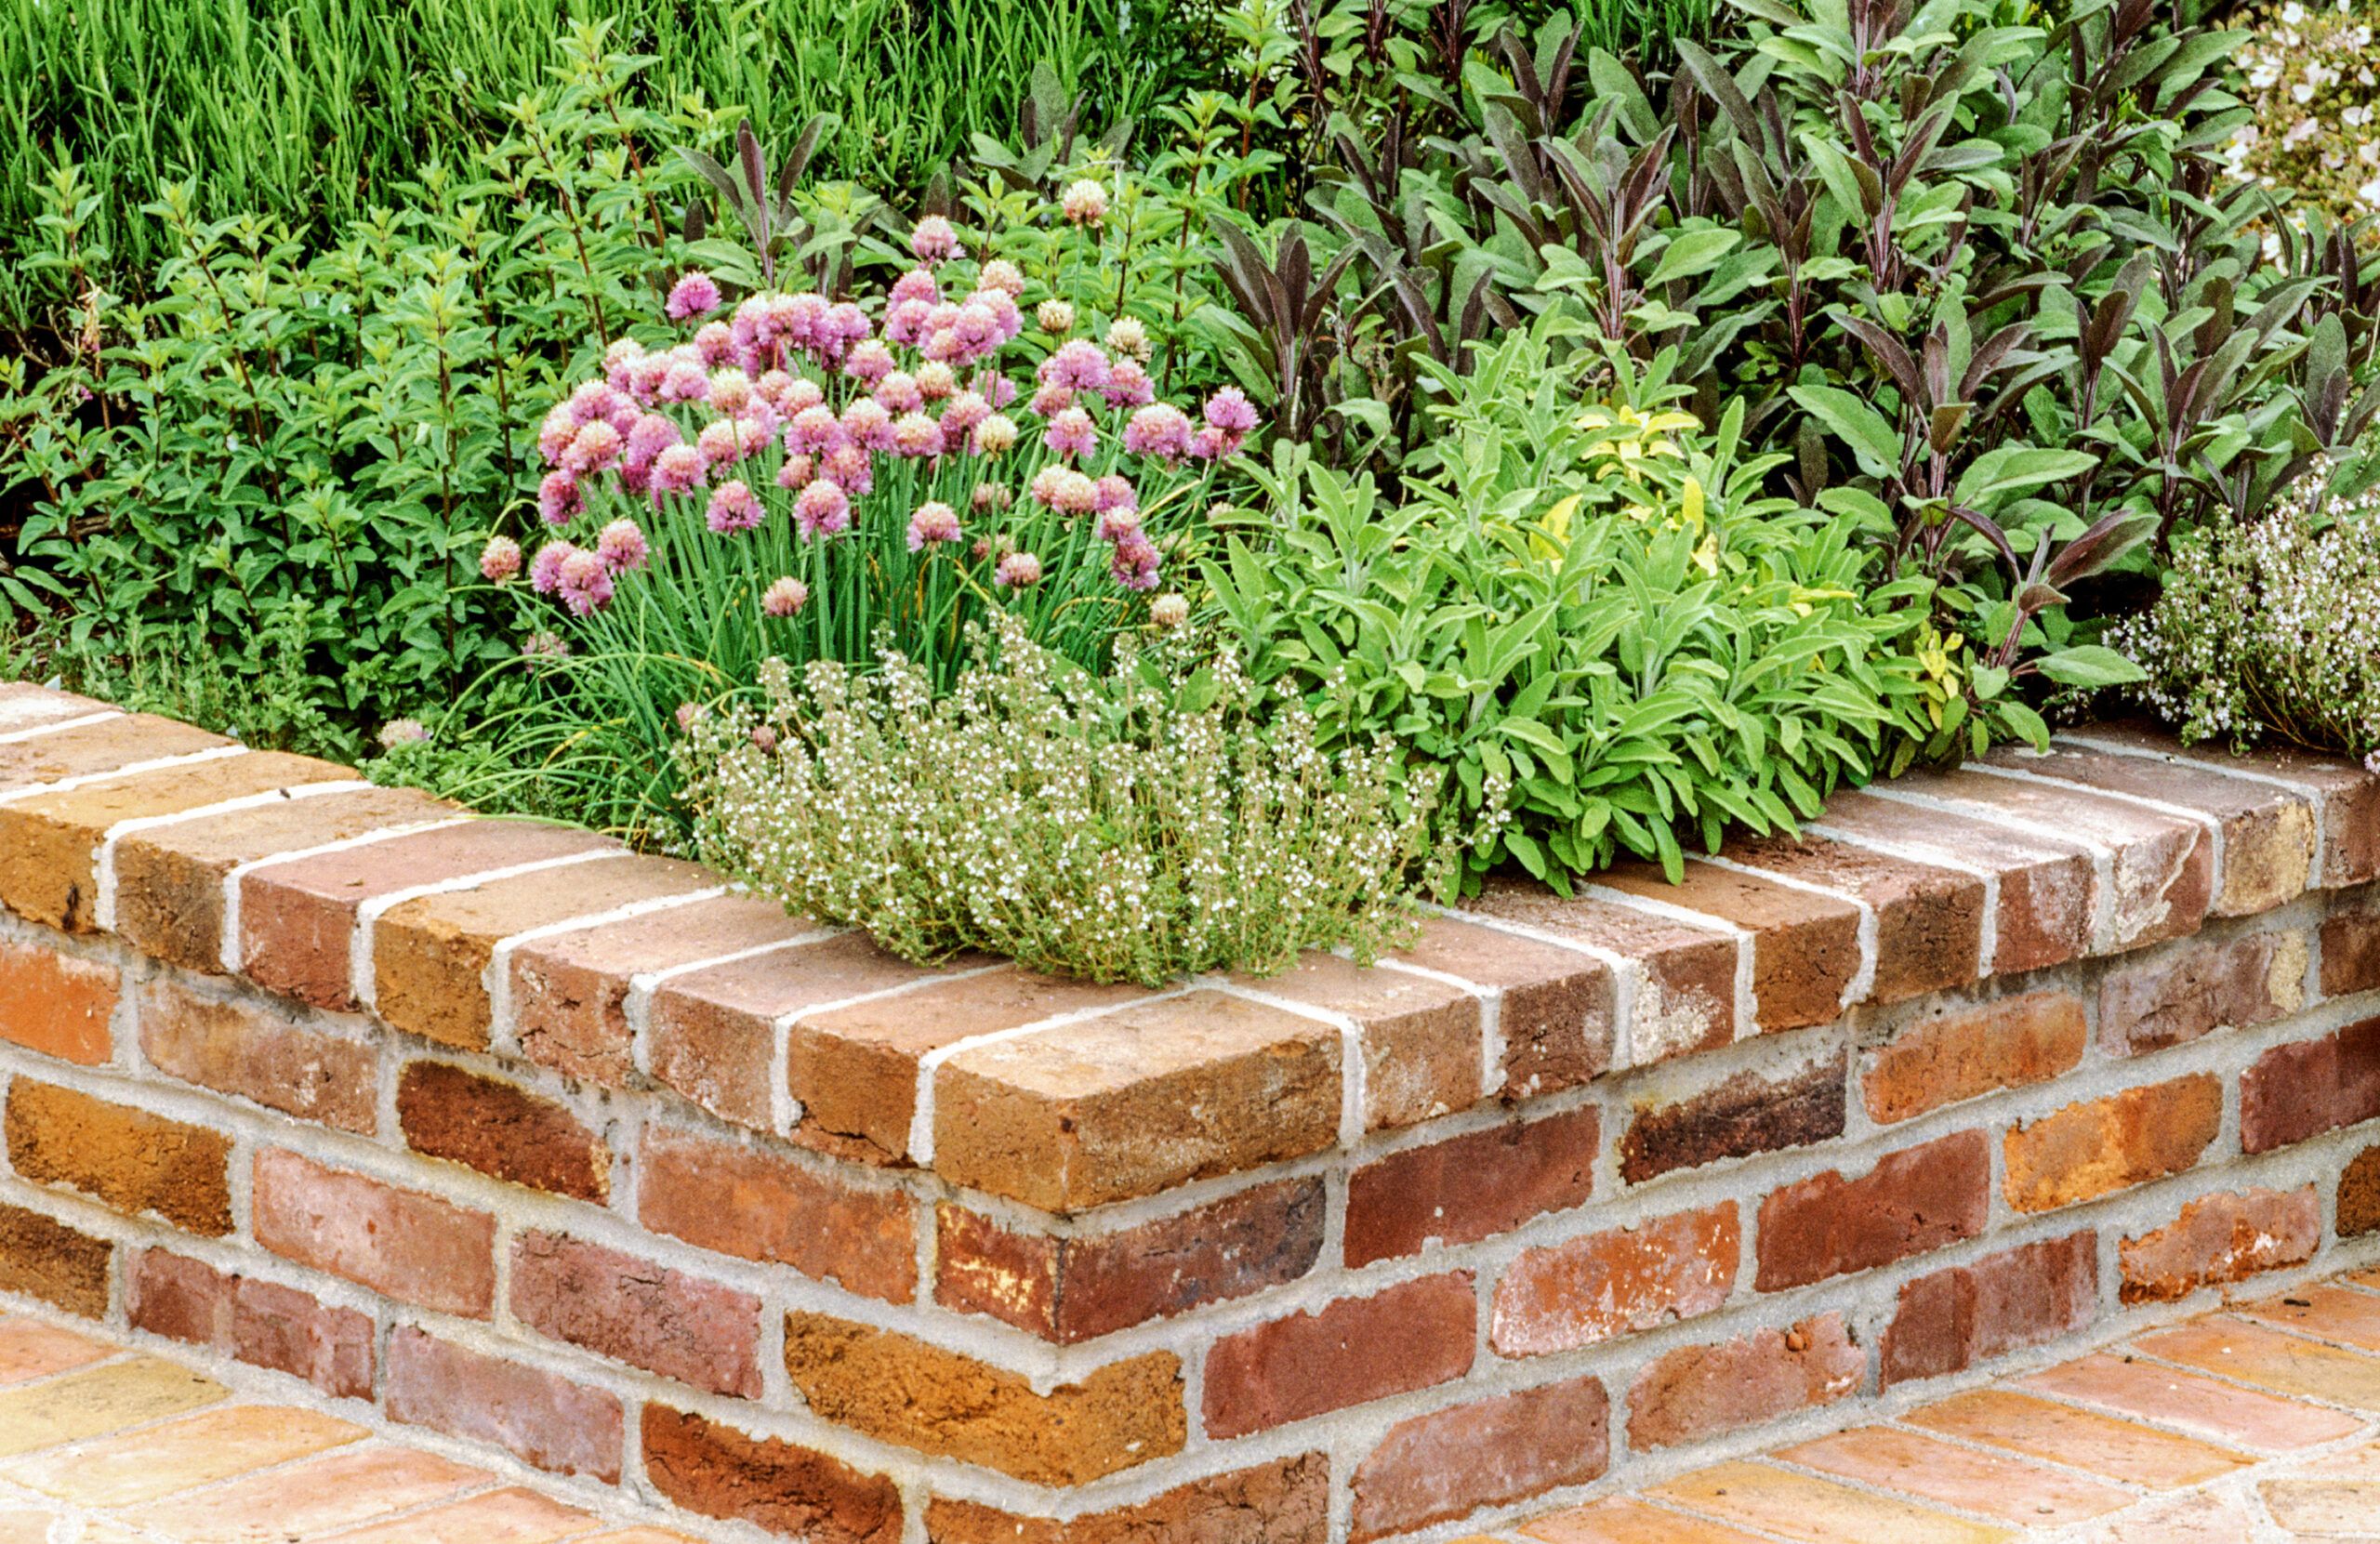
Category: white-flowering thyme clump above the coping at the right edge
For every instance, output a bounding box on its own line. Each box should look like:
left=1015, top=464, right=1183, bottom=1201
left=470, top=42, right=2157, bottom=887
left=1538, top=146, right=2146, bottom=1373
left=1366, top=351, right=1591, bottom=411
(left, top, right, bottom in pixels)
left=2109, top=462, right=2380, bottom=773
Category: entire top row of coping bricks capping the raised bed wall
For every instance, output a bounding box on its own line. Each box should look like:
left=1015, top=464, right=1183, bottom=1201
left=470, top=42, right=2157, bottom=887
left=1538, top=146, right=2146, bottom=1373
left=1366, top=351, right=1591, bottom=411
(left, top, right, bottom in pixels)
left=0, top=685, right=2380, bottom=1213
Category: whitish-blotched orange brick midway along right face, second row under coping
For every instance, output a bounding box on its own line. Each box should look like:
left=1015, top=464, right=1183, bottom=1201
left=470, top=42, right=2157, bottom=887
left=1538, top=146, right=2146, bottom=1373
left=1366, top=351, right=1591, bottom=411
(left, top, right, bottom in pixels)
left=1488, top=1201, right=1742, bottom=1356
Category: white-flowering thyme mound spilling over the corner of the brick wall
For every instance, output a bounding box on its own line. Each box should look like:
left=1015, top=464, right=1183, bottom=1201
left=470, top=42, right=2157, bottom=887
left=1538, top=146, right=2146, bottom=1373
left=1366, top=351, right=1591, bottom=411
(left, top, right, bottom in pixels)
left=679, top=628, right=1457, bottom=985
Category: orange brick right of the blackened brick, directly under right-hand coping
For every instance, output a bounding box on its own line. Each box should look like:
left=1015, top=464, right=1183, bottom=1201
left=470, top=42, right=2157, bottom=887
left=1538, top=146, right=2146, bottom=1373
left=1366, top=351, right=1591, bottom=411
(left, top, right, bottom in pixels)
left=1858, top=992, right=2090, bottom=1126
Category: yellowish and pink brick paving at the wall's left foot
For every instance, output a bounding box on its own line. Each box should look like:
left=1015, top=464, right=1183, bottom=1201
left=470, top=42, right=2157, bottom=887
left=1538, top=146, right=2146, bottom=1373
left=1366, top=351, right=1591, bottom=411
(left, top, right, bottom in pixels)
left=0, top=1315, right=697, bottom=1544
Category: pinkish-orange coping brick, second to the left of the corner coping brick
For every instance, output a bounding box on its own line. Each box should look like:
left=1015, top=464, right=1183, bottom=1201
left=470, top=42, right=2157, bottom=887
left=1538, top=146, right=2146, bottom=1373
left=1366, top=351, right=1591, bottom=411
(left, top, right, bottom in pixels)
left=647, top=932, right=961, bottom=1132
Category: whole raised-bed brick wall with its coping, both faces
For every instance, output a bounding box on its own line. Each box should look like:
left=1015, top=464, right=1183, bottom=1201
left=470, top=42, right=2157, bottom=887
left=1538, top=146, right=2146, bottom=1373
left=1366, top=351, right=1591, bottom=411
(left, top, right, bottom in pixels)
left=0, top=688, right=2380, bottom=1544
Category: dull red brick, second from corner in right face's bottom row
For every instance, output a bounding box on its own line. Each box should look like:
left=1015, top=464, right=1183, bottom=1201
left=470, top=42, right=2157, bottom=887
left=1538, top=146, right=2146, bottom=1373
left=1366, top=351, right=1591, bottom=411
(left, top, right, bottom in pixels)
left=1350, top=1378, right=1611, bottom=1544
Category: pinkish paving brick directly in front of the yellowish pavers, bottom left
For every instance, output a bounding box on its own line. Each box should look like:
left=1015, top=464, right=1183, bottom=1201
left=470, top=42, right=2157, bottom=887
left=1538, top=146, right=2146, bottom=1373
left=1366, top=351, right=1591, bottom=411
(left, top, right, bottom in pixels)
left=124, top=1445, right=495, bottom=1544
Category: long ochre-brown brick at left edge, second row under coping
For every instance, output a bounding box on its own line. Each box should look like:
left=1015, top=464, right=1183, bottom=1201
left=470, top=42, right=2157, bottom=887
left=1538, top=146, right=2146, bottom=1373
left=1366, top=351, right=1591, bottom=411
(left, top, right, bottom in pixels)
left=7, top=1077, right=231, bottom=1237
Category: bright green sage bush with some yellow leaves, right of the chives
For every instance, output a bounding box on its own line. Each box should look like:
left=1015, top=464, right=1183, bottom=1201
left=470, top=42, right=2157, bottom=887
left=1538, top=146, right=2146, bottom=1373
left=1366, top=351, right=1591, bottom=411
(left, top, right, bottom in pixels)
left=1207, top=322, right=1964, bottom=890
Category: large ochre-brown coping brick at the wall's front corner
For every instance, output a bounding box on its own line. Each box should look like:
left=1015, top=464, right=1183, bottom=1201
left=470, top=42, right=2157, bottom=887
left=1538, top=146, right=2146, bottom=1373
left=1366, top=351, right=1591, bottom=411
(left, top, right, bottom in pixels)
left=933, top=992, right=1340, bottom=1211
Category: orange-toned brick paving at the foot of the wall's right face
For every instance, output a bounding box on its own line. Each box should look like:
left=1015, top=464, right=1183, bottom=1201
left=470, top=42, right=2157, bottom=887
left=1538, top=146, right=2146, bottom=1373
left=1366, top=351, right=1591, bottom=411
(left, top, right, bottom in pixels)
left=1503, top=1271, right=2380, bottom=1544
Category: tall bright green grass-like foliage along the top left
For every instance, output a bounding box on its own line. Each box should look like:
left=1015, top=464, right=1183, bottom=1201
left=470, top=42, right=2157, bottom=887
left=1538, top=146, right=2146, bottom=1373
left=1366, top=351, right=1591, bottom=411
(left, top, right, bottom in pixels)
left=0, top=0, right=1171, bottom=319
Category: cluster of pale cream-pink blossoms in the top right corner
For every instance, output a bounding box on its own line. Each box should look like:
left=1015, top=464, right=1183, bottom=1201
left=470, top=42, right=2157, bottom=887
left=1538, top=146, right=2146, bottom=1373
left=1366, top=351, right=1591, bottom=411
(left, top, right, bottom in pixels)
left=2223, top=0, right=2380, bottom=218
